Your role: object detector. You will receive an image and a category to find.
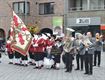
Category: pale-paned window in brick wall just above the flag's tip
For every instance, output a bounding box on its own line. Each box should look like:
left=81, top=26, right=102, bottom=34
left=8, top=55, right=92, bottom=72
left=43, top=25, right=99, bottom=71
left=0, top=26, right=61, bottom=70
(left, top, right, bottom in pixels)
left=13, top=2, right=30, bottom=14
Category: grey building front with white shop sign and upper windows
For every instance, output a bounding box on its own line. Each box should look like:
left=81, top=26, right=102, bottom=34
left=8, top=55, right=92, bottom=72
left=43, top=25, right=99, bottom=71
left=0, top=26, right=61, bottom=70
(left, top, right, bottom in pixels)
left=65, top=0, right=105, bottom=33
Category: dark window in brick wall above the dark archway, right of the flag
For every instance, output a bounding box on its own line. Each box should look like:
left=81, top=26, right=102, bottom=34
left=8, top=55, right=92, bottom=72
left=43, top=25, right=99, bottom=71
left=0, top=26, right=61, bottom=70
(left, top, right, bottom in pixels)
left=39, top=2, right=54, bottom=15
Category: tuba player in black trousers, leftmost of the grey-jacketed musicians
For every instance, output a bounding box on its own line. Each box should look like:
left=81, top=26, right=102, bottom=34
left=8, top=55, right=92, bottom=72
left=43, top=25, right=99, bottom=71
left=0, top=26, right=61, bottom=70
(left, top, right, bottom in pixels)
left=63, top=36, right=74, bottom=72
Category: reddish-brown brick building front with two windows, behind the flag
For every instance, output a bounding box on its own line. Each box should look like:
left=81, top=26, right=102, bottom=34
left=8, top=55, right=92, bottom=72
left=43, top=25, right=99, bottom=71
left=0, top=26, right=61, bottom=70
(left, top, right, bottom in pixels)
left=0, top=0, right=64, bottom=36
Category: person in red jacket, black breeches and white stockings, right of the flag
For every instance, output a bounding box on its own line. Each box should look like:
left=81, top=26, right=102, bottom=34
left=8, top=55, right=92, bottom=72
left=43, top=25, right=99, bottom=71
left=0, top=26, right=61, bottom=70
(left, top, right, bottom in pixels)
left=33, top=34, right=46, bottom=69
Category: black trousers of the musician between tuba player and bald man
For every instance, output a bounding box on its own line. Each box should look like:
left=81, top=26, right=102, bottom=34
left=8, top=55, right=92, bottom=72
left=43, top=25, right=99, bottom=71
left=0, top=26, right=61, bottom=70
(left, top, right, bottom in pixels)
left=76, top=54, right=84, bottom=70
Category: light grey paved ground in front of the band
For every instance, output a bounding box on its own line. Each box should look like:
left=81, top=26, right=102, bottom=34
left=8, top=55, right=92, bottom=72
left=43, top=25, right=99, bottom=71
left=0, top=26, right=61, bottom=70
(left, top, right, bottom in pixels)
left=0, top=52, right=105, bottom=80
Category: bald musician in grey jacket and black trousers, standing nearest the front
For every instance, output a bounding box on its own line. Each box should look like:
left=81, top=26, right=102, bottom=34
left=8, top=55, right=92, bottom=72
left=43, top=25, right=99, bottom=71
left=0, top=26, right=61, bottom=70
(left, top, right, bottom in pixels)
left=84, top=32, right=94, bottom=75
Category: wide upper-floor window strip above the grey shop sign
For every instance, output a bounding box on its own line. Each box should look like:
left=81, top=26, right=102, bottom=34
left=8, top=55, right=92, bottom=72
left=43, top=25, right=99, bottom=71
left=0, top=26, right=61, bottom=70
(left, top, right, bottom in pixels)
left=68, top=0, right=105, bottom=11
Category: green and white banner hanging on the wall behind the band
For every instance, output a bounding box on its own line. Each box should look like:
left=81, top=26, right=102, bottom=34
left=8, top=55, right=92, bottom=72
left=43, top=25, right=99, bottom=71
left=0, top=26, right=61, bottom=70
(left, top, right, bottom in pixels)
left=52, top=17, right=63, bottom=36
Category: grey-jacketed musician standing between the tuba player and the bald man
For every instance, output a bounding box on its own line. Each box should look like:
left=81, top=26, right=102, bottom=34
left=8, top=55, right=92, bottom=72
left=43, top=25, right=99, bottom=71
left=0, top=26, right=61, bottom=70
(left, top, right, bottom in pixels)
left=74, top=34, right=85, bottom=71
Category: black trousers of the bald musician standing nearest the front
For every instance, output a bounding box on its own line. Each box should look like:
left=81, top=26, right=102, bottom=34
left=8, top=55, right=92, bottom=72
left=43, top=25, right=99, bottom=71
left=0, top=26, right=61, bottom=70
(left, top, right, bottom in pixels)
left=85, top=52, right=93, bottom=74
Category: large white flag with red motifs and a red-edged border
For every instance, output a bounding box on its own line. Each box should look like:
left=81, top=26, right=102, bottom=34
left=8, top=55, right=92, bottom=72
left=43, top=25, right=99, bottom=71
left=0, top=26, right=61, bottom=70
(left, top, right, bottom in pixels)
left=10, top=11, right=32, bottom=56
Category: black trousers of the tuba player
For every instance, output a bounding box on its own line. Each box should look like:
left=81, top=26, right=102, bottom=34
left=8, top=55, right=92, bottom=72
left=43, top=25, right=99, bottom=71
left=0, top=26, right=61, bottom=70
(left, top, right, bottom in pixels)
left=65, top=53, right=73, bottom=71
